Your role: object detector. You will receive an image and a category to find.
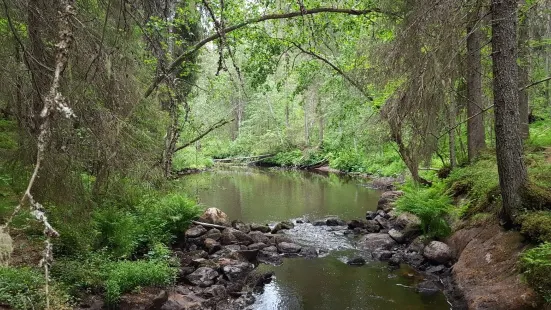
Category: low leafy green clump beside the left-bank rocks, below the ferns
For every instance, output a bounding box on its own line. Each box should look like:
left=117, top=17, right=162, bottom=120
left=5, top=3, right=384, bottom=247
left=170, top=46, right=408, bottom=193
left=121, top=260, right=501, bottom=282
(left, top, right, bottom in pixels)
left=105, top=260, right=177, bottom=304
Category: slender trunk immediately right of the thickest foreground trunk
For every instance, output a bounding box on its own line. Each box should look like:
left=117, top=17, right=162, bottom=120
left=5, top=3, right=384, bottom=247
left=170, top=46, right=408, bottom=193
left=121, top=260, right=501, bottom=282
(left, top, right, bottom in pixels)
left=518, top=0, right=530, bottom=139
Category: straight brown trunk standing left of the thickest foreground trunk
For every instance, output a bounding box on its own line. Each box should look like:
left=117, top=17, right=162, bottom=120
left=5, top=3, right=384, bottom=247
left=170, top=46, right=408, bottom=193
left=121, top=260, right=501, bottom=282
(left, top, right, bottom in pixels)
left=467, top=8, right=486, bottom=162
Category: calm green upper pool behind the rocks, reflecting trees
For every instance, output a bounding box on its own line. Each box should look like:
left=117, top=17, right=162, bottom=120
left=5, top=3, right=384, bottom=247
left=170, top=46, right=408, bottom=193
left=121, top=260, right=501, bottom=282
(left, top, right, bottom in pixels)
left=179, top=169, right=378, bottom=222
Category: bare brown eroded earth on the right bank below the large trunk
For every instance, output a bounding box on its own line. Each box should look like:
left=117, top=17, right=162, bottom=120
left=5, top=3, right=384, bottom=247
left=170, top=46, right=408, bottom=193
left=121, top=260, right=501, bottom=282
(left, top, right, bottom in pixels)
left=447, top=223, right=542, bottom=310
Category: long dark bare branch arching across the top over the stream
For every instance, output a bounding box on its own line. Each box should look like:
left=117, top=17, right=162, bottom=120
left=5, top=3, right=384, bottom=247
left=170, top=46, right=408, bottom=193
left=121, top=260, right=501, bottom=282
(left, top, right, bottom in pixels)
left=144, top=8, right=383, bottom=98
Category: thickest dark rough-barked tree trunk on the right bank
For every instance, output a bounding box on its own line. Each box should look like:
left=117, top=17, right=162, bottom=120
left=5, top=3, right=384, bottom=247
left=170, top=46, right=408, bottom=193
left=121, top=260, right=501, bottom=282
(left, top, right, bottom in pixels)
left=491, top=0, right=528, bottom=223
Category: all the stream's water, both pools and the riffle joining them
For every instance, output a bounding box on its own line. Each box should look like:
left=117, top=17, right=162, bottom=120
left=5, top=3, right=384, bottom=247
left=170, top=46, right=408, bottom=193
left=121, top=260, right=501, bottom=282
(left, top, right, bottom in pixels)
left=182, top=168, right=450, bottom=310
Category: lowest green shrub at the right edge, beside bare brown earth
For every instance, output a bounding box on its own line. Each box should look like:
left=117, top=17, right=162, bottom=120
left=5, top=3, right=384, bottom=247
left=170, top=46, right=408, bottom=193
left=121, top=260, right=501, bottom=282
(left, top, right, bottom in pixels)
left=520, top=242, right=551, bottom=302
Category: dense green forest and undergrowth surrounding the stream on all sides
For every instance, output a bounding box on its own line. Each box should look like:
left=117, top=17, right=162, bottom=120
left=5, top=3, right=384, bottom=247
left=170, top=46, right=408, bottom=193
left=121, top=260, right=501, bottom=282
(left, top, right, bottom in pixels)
left=0, top=0, right=551, bottom=309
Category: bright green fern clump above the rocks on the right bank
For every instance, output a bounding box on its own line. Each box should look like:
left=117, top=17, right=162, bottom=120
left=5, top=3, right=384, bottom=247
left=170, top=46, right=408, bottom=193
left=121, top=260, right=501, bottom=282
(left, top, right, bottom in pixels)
left=396, top=183, right=452, bottom=238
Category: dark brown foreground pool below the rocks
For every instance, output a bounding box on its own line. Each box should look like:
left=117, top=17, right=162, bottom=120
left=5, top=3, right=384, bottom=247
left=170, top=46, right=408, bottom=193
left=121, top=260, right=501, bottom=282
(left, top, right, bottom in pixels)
left=264, top=254, right=447, bottom=310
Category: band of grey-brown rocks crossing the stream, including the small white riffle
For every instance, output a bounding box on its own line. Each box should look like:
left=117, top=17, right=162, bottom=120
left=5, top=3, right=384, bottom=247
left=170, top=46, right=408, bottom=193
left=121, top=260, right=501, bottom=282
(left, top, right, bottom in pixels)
left=80, top=191, right=466, bottom=310
